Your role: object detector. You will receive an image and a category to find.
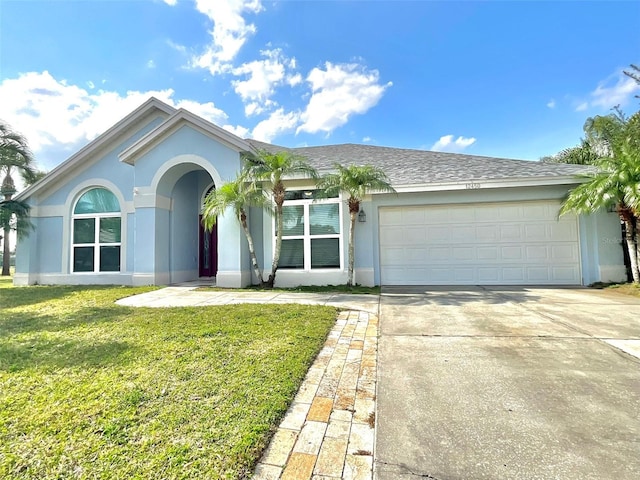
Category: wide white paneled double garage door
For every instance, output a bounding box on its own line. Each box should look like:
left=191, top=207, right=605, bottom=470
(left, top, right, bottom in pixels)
left=379, top=202, right=581, bottom=285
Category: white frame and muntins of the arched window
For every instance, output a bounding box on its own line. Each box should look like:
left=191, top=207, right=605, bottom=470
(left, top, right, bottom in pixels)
left=69, top=189, right=123, bottom=275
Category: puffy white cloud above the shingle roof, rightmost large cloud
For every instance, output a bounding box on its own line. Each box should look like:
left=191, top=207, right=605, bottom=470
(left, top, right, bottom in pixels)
left=297, top=62, right=392, bottom=133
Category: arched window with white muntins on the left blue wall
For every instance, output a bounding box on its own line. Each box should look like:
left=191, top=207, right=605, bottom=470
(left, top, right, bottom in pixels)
left=72, top=188, right=121, bottom=272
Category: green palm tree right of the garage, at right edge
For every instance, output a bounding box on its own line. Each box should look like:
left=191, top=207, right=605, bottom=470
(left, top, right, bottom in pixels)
left=560, top=110, right=640, bottom=283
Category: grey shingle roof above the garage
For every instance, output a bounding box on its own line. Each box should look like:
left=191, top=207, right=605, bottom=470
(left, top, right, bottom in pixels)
left=247, top=140, right=590, bottom=186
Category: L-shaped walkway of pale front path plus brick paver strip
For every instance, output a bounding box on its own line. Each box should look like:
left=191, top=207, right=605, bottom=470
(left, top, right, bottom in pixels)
left=116, top=285, right=380, bottom=480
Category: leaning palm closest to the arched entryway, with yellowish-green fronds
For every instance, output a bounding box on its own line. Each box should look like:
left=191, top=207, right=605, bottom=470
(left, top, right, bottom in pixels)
left=202, top=174, right=270, bottom=286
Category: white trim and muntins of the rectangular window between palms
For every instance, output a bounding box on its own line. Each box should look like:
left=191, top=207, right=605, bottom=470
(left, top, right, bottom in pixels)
left=271, top=194, right=344, bottom=272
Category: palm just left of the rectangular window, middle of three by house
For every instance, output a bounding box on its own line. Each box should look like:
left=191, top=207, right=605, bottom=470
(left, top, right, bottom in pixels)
left=245, top=150, right=318, bottom=288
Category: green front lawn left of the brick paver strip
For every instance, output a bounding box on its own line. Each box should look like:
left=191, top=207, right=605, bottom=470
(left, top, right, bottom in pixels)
left=0, top=279, right=336, bottom=480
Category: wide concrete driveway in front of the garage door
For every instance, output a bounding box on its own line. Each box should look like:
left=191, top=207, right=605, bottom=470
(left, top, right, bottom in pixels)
left=375, top=287, right=640, bottom=480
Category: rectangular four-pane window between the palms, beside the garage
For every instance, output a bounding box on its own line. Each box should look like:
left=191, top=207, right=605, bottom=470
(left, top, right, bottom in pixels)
left=278, top=190, right=342, bottom=270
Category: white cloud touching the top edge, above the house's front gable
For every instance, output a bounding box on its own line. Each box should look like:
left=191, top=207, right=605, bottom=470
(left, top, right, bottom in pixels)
left=191, top=0, right=263, bottom=75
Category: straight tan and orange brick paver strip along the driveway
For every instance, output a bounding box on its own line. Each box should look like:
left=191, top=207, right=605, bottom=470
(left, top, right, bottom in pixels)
left=253, top=311, right=378, bottom=480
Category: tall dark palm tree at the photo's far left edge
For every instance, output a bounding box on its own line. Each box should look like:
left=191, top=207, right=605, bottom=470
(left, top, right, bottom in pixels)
left=0, top=122, right=36, bottom=276
